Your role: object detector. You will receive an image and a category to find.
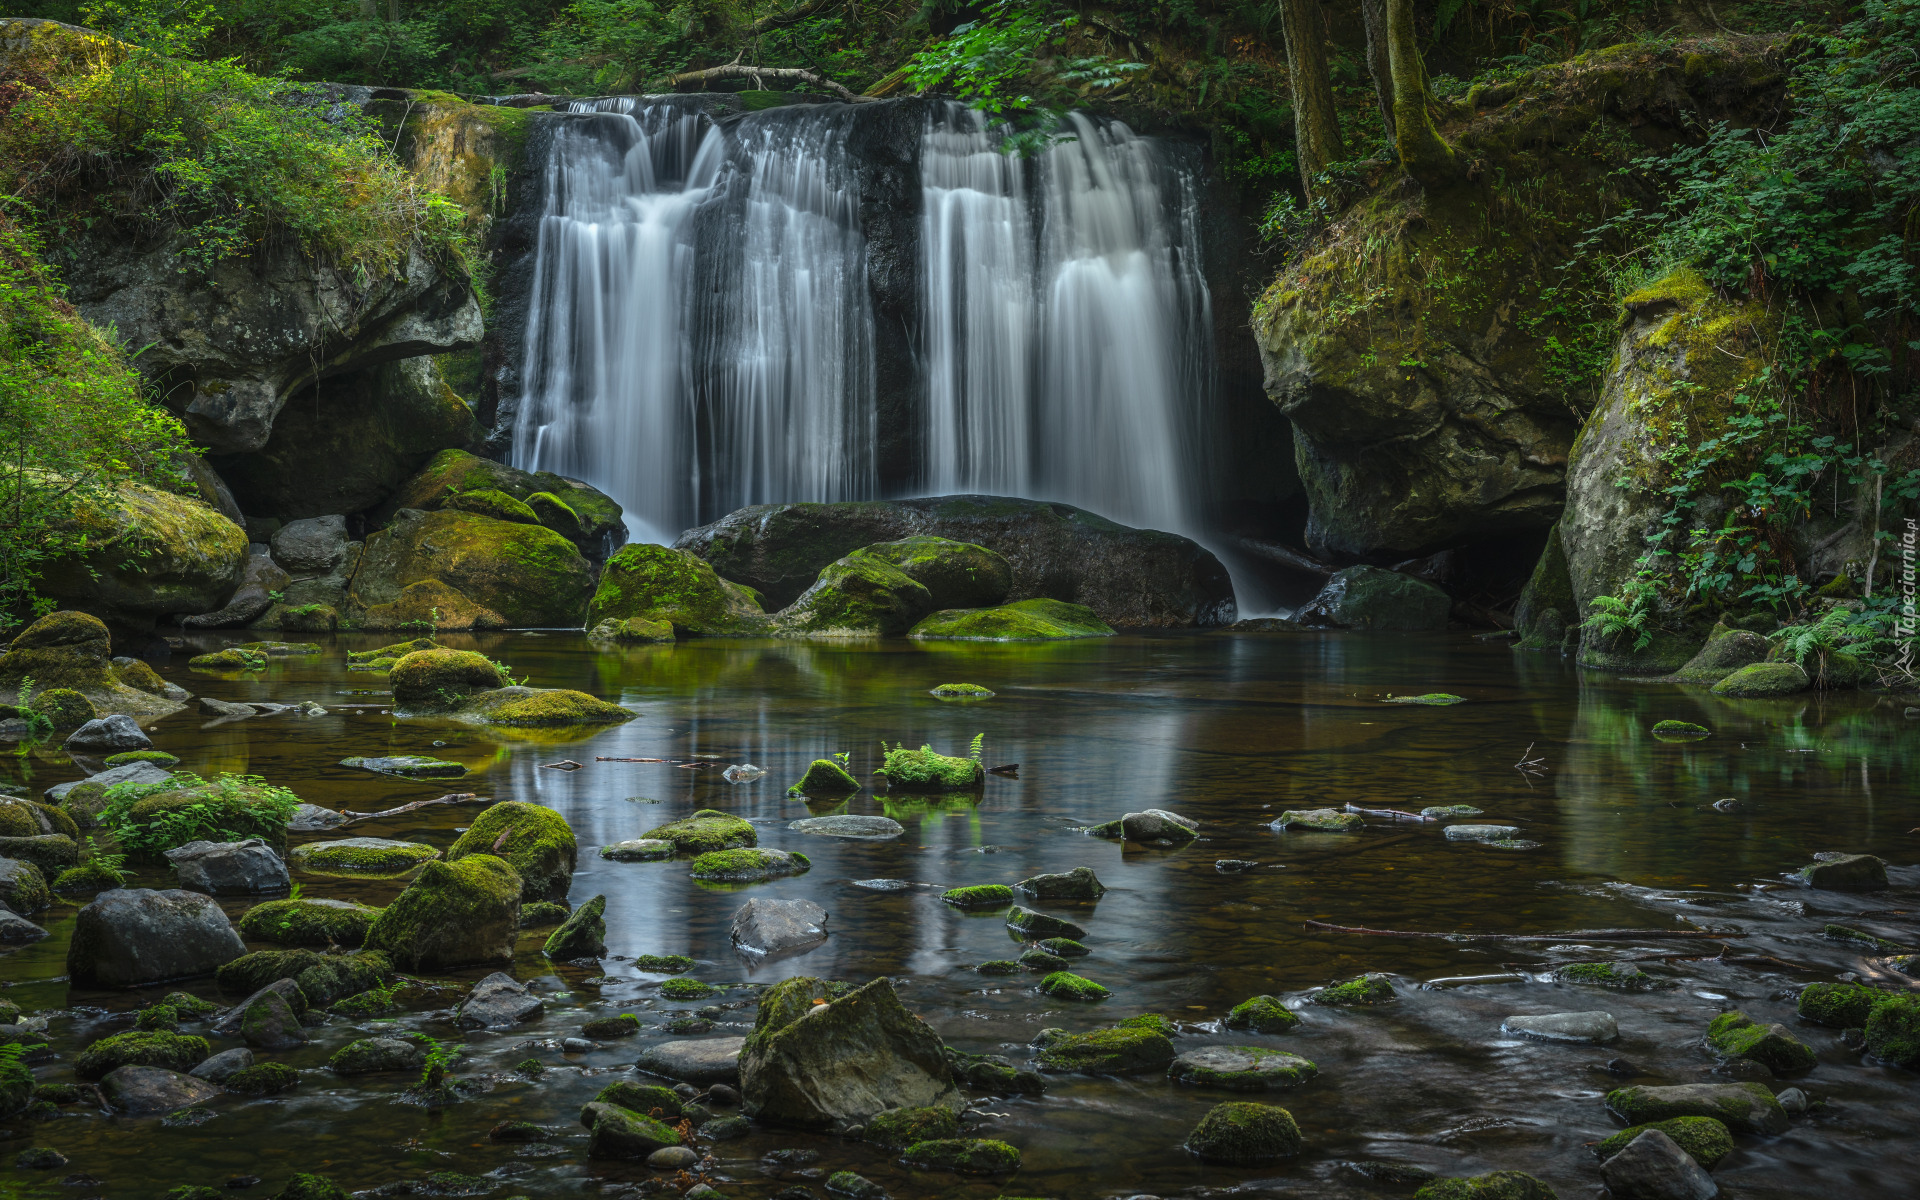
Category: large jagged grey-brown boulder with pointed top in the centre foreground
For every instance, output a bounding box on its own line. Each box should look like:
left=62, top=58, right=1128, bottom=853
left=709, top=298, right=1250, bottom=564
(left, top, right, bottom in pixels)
left=739, top=977, right=964, bottom=1129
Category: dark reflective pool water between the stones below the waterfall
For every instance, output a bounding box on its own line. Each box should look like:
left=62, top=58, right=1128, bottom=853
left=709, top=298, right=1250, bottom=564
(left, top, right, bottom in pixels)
left=0, top=632, right=1920, bottom=1200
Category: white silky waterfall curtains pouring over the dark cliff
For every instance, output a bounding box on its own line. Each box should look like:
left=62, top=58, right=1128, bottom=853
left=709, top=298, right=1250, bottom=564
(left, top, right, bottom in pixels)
left=515, top=96, right=1212, bottom=541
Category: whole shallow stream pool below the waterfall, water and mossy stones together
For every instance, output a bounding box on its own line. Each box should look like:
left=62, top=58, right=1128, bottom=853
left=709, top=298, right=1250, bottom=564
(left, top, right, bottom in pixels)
left=0, top=630, right=1920, bottom=1200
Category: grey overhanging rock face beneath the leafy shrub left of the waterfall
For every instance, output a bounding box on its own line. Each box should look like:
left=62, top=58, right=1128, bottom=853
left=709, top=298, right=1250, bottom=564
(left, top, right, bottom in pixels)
left=69, top=234, right=482, bottom=453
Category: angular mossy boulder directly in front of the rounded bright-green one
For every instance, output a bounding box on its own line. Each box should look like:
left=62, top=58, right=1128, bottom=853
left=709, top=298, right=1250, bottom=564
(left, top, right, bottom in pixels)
left=367, top=856, right=520, bottom=972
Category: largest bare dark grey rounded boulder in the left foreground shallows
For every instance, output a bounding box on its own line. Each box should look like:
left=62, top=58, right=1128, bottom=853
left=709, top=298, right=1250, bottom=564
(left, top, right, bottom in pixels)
left=67, top=887, right=246, bottom=987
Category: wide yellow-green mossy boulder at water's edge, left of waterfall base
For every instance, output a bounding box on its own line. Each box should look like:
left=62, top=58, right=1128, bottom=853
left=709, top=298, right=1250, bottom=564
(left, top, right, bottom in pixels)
left=348, top=509, right=593, bottom=628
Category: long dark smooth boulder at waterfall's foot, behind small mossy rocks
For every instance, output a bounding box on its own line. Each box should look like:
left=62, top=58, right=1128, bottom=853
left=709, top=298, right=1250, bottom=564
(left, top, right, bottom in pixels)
left=674, top=495, right=1236, bottom=626
